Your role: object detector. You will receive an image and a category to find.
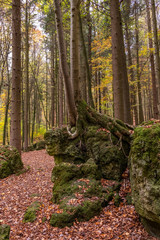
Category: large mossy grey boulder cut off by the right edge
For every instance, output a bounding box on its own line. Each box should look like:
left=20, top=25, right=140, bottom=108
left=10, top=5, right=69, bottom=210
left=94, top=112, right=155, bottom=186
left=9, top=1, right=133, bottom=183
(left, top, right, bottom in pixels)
left=130, top=122, right=160, bottom=238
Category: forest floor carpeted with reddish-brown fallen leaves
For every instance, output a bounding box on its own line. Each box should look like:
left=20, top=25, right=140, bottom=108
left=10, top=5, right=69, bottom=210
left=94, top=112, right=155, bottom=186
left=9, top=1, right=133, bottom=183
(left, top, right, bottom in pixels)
left=0, top=150, right=156, bottom=240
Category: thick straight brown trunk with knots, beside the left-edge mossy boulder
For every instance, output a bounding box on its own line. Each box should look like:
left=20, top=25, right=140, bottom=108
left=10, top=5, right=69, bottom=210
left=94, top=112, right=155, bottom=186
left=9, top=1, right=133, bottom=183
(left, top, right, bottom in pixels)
left=10, top=0, right=21, bottom=153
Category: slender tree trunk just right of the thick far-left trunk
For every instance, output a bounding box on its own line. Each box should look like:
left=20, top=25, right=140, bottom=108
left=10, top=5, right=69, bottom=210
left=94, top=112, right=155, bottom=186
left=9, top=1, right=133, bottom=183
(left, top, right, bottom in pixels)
left=24, top=0, right=29, bottom=150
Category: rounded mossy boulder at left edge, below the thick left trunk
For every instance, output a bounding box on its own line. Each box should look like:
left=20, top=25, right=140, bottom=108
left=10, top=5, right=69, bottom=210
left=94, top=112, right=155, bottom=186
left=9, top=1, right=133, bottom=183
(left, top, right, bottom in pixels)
left=0, top=146, right=23, bottom=179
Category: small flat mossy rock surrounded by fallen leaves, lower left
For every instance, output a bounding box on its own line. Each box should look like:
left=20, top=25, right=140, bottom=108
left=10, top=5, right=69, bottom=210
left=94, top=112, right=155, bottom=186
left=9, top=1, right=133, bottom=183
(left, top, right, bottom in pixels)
left=23, top=202, right=41, bottom=223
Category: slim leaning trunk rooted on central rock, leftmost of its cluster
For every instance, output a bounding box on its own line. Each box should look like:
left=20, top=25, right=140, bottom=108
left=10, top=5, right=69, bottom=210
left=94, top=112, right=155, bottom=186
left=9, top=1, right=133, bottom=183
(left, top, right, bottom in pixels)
left=54, top=0, right=77, bottom=125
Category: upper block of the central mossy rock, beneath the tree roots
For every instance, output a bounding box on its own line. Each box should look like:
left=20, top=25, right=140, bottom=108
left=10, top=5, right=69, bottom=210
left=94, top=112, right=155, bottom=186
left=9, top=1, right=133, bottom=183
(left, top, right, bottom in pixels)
left=45, top=125, right=130, bottom=180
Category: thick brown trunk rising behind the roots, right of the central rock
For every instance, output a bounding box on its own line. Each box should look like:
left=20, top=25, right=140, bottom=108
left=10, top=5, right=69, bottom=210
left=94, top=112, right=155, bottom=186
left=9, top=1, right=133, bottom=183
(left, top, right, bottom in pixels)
left=110, top=0, right=131, bottom=123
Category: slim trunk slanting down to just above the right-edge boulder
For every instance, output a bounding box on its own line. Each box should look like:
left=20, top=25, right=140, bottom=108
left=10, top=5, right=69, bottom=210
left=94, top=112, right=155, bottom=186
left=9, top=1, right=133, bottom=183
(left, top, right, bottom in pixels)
left=145, top=0, right=158, bottom=119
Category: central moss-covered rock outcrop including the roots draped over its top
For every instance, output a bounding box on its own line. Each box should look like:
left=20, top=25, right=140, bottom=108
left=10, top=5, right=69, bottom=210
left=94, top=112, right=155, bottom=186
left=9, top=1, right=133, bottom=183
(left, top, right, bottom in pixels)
left=44, top=101, right=130, bottom=227
